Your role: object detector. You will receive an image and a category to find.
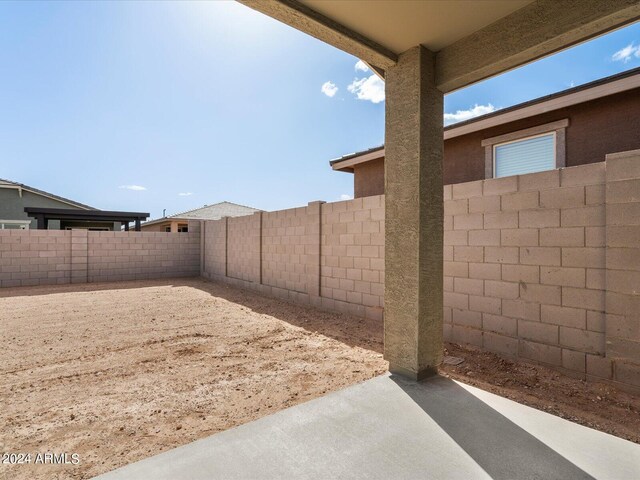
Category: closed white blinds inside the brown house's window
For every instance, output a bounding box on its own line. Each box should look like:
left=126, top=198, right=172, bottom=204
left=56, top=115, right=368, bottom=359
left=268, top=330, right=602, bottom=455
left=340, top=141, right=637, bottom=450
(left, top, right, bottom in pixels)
left=493, top=133, right=556, bottom=177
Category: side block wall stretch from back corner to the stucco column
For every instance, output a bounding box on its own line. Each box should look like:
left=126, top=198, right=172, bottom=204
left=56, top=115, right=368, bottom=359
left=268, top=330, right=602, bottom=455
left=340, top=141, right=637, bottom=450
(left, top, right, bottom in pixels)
left=202, top=196, right=384, bottom=320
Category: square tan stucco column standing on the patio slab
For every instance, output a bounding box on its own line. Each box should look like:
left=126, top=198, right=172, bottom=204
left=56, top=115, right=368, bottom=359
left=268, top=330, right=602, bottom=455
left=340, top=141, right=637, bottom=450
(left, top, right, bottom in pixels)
left=384, top=47, right=443, bottom=379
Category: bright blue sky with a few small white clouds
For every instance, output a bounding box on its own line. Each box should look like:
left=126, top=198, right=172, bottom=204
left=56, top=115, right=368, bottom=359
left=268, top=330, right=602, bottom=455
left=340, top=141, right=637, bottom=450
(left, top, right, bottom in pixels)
left=0, top=1, right=640, bottom=217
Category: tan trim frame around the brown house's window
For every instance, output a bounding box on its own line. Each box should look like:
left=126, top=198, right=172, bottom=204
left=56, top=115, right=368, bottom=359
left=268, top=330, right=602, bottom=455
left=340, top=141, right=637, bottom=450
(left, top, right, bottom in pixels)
left=481, top=118, right=569, bottom=178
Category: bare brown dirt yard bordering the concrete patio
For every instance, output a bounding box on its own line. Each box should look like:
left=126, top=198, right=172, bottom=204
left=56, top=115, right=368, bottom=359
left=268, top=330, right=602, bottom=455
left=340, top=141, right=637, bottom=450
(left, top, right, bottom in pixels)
left=0, top=279, right=640, bottom=479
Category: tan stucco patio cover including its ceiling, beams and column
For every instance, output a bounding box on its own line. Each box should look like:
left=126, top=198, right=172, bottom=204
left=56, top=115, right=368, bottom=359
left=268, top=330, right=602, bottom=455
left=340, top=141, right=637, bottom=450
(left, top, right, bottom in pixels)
left=239, top=0, right=640, bottom=379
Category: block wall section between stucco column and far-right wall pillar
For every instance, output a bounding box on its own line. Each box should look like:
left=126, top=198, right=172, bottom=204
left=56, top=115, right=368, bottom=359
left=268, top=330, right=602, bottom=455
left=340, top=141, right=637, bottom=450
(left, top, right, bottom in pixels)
left=444, top=162, right=606, bottom=376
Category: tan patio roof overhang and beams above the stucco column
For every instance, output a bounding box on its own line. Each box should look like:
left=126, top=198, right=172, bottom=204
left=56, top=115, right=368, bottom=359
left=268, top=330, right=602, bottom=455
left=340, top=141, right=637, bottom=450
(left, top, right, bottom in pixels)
left=238, top=0, right=640, bottom=93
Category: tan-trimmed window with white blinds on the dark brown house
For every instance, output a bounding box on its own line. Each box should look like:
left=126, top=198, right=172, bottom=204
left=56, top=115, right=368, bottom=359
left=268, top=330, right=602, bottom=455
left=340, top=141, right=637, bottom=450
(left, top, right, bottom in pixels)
left=482, top=118, right=569, bottom=178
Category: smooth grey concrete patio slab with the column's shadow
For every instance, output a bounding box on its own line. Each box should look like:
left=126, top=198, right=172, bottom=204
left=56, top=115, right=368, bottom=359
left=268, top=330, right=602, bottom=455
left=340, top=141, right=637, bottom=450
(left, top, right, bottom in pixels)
left=97, top=375, right=640, bottom=480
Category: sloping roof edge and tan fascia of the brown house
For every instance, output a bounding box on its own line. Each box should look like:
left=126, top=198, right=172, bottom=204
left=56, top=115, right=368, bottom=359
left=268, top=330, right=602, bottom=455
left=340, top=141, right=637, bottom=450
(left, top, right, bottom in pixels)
left=329, top=67, right=640, bottom=171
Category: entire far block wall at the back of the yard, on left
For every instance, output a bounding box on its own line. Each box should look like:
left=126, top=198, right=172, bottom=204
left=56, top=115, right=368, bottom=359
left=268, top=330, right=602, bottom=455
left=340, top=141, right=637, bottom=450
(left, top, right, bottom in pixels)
left=0, top=222, right=200, bottom=287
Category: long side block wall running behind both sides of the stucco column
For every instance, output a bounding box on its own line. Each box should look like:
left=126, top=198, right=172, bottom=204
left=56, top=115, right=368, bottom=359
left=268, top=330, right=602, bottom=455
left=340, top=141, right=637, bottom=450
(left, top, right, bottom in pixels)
left=202, top=151, right=640, bottom=387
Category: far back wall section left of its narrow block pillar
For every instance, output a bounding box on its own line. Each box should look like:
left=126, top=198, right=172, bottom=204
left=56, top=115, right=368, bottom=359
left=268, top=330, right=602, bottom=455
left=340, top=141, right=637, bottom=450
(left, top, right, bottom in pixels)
left=0, top=230, right=71, bottom=287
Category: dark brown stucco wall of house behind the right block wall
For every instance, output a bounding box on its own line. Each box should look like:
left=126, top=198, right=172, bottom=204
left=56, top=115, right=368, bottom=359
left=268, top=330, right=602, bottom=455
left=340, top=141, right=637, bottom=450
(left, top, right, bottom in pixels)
left=353, top=89, right=640, bottom=198
